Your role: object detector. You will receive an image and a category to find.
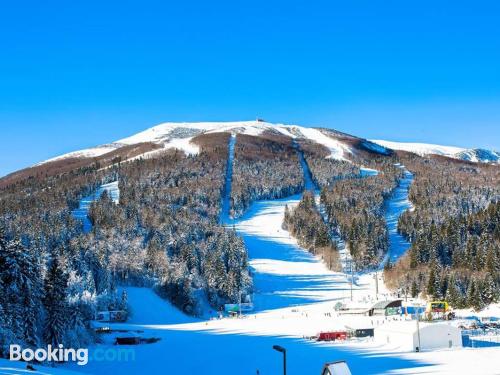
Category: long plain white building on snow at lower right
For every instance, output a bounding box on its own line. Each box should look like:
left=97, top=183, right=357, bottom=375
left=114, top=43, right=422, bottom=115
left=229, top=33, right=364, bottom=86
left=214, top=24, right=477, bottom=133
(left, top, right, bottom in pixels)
left=375, top=320, right=462, bottom=351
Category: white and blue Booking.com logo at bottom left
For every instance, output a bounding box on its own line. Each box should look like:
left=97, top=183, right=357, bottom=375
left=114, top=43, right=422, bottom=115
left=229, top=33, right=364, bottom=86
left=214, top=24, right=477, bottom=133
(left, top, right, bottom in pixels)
left=9, top=344, right=135, bottom=366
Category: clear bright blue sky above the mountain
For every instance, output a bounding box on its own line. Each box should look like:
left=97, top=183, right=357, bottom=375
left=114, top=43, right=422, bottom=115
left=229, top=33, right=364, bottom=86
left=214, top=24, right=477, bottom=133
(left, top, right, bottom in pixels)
left=0, top=0, right=500, bottom=175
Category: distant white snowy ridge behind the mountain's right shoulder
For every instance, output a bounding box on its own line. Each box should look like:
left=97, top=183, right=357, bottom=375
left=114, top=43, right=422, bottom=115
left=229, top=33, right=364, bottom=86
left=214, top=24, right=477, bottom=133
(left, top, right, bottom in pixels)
left=371, top=139, right=500, bottom=163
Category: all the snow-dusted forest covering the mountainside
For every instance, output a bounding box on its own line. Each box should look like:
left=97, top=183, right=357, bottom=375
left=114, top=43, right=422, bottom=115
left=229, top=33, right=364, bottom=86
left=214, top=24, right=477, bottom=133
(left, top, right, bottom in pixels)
left=0, top=127, right=500, bottom=356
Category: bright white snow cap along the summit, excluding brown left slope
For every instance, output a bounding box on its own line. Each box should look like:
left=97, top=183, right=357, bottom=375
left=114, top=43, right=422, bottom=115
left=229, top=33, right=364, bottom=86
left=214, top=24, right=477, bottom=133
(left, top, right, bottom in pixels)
left=37, top=121, right=500, bottom=166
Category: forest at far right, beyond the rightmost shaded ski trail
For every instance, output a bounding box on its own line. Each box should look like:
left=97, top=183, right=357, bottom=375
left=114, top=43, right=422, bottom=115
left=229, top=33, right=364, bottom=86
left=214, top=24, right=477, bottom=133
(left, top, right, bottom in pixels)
left=386, top=154, right=500, bottom=310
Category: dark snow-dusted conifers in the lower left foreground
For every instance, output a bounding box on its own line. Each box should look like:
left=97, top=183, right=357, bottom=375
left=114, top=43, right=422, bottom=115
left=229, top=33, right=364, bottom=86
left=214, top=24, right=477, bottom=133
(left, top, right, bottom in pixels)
left=0, top=225, right=128, bottom=357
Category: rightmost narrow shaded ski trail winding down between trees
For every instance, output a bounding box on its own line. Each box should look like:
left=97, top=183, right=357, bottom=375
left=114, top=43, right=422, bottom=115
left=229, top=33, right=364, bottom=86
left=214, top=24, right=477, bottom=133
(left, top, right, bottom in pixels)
left=380, top=165, right=413, bottom=268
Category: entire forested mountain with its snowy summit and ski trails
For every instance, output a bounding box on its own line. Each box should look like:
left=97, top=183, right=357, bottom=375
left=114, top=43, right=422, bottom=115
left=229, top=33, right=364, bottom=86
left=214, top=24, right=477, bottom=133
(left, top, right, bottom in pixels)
left=0, top=121, right=500, bottom=370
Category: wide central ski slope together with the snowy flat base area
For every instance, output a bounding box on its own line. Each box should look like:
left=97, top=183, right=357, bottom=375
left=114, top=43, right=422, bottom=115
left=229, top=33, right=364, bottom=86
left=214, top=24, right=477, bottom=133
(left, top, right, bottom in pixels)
left=54, top=162, right=499, bottom=375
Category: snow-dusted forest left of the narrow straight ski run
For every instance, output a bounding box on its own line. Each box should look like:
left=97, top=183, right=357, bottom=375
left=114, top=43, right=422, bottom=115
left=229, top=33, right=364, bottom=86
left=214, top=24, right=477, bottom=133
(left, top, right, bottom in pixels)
left=0, top=134, right=251, bottom=356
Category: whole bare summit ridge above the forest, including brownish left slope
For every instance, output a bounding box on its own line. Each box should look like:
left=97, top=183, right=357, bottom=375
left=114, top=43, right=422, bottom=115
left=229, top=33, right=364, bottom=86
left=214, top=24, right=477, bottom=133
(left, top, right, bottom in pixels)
left=0, top=120, right=500, bottom=186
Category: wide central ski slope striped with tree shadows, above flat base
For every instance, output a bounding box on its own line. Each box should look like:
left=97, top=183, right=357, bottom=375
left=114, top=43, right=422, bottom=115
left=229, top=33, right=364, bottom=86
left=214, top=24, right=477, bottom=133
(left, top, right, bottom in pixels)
left=234, top=195, right=350, bottom=311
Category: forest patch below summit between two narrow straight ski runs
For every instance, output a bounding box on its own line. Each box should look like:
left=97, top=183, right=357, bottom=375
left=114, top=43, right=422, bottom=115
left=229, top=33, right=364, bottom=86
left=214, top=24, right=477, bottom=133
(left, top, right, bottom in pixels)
left=231, top=133, right=304, bottom=217
